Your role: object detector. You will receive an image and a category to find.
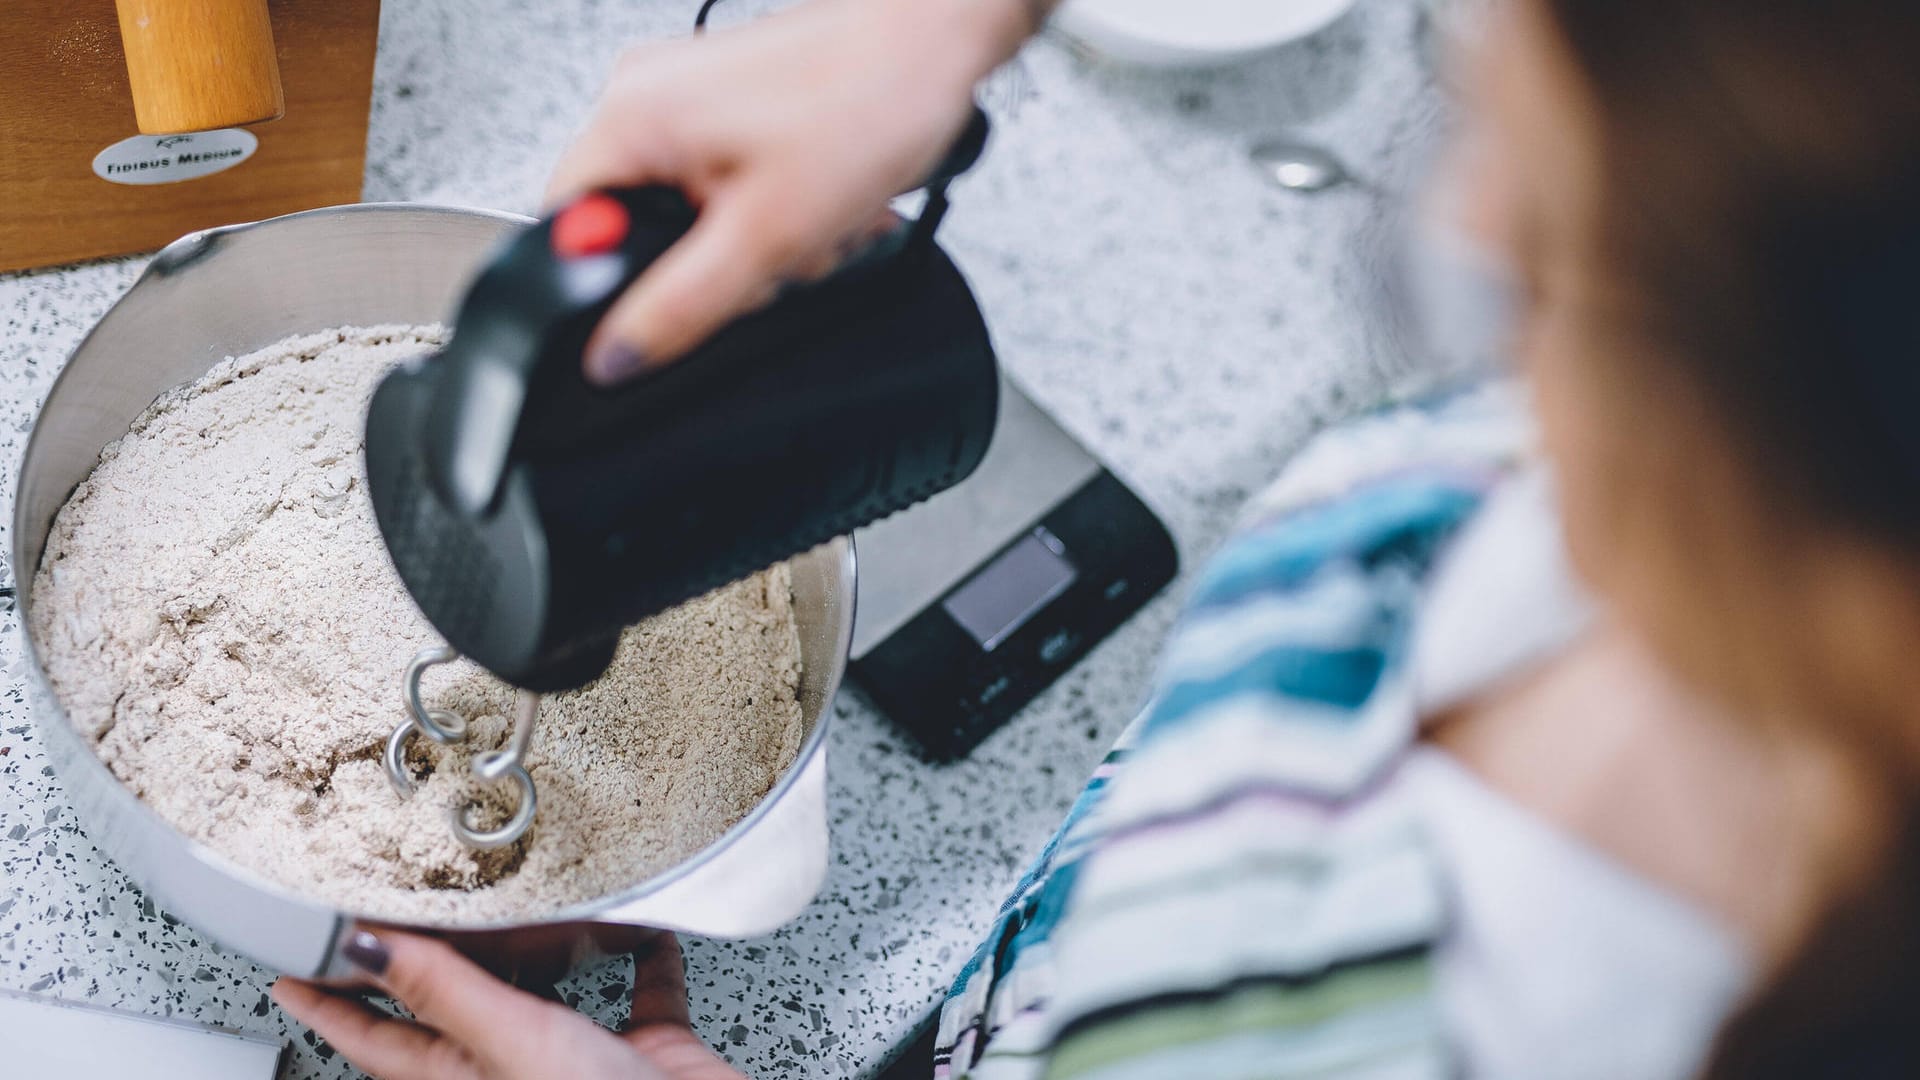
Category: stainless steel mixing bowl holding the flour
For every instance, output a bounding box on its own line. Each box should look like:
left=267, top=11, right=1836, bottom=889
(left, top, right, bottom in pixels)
left=13, top=204, right=854, bottom=976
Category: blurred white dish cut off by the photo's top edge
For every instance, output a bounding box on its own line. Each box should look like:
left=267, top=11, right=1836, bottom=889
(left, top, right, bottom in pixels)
left=1052, top=0, right=1354, bottom=67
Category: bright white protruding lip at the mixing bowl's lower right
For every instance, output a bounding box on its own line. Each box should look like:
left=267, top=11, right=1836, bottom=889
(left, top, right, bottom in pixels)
left=595, top=746, right=828, bottom=938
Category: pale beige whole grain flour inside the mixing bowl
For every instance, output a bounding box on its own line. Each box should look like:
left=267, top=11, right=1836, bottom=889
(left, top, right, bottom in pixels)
left=33, top=327, right=801, bottom=922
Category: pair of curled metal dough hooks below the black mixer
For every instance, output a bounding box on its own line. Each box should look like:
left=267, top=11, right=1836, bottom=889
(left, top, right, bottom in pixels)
left=384, top=646, right=540, bottom=851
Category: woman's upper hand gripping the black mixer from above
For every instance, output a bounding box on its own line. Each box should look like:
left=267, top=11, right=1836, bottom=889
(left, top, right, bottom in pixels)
left=547, top=0, right=1050, bottom=382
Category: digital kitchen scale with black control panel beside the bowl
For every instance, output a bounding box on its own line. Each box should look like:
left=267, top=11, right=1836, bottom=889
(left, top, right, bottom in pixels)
left=849, top=379, right=1179, bottom=761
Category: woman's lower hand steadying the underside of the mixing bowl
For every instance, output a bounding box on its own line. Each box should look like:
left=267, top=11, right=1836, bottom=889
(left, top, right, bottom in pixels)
left=273, top=930, right=741, bottom=1080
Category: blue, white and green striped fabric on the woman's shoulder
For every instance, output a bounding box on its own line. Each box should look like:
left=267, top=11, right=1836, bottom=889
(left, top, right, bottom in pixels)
left=935, top=390, right=1492, bottom=1080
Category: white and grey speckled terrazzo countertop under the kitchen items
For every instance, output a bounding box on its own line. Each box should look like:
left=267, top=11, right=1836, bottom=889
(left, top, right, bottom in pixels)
left=0, top=0, right=1436, bottom=1080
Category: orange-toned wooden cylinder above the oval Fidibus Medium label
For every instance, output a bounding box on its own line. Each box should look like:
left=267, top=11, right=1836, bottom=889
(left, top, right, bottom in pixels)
left=115, top=0, right=286, bottom=135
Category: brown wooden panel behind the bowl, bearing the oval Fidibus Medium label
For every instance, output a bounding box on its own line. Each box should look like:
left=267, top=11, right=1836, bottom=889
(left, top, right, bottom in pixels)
left=0, top=0, right=380, bottom=271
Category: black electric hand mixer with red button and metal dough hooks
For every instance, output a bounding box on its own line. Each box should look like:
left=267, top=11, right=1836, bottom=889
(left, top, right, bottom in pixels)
left=367, top=110, right=998, bottom=847
